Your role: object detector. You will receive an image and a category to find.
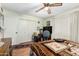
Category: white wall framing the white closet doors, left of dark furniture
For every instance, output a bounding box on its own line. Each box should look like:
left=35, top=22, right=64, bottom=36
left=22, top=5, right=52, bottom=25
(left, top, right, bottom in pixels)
left=4, top=9, right=42, bottom=44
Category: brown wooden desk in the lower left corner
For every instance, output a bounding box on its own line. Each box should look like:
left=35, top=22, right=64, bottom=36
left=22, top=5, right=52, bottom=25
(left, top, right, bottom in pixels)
left=0, top=38, right=12, bottom=56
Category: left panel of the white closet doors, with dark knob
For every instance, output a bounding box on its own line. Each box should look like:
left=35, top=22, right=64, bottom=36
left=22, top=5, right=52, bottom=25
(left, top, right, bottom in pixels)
left=16, top=20, right=29, bottom=44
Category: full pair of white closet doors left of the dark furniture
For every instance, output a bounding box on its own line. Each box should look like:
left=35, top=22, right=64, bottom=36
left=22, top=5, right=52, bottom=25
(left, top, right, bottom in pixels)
left=16, top=20, right=37, bottom=44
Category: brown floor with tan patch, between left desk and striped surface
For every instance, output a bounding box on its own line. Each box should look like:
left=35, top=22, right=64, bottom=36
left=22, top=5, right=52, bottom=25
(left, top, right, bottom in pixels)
left=11, top=42, right=32, bottom=56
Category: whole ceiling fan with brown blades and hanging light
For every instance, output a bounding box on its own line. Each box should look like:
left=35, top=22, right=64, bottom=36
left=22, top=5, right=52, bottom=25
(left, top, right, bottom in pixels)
left=36, top=3, right=62, bottom=14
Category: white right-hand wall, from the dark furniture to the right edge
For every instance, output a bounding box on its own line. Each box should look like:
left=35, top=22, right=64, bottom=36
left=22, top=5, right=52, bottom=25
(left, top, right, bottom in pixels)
left=44, top=8, right=79, bottom=42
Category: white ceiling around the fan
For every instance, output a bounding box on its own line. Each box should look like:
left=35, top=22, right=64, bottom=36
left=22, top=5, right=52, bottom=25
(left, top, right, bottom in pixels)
left=2, top=3, right=79, bottom=18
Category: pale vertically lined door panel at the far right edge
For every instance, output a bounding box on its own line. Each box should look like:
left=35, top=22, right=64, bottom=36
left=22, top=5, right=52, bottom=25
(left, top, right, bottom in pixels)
left=70, top=12, right=79, bottom=42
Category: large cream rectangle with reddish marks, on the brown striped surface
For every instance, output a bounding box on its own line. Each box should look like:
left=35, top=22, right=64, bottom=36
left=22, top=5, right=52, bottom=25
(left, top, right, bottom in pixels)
left=44, top=42, right=67, bottom=53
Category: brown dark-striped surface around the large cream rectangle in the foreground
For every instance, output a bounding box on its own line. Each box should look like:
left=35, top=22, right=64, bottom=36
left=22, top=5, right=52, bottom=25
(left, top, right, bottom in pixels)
left=31, top=40, right=79, bottom=56
